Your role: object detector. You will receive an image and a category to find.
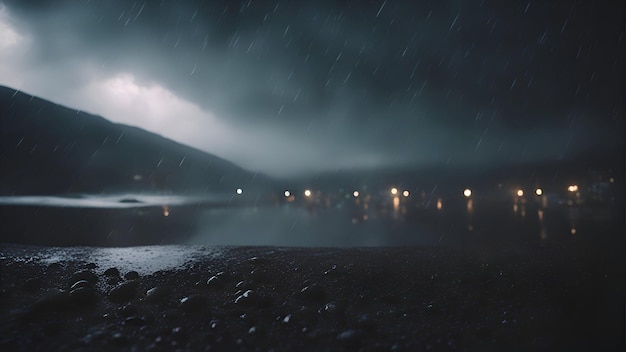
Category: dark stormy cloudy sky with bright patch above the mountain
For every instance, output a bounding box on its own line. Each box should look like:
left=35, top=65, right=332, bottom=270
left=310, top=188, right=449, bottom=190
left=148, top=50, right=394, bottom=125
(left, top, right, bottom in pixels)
left=0, top=0, right=625, bottom=176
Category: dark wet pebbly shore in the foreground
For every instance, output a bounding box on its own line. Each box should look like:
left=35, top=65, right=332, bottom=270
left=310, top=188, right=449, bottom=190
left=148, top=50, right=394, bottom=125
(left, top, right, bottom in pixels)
left=0, top=245, right=625, bottom=351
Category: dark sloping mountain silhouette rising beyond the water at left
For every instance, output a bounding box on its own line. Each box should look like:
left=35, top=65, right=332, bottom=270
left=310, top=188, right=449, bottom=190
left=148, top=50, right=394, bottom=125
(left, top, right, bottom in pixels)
left=0, top=87, right=266, bottom=195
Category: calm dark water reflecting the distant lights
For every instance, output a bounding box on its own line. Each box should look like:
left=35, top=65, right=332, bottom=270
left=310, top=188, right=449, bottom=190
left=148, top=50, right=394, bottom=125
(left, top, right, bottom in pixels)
left=0, top=195, right=623, bottom=247
